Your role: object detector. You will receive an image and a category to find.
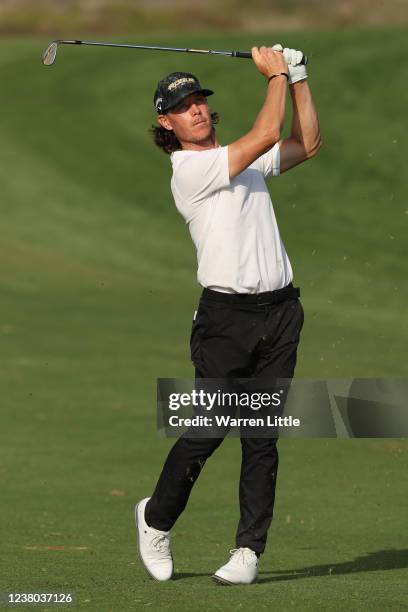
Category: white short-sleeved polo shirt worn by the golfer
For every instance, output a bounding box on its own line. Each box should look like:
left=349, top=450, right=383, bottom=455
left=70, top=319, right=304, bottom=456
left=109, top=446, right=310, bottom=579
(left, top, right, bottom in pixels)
left=171, top=144, right=293, bottom=293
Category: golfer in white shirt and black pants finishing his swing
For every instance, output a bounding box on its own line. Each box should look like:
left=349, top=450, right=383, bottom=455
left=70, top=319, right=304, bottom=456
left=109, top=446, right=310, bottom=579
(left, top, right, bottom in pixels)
left=135, top=45, right=321, bottom=585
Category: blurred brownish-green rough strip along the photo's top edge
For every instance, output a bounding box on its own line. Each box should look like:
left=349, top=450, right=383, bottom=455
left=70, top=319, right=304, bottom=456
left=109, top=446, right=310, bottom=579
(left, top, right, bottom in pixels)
left=0, top=0, right=408, bottom=34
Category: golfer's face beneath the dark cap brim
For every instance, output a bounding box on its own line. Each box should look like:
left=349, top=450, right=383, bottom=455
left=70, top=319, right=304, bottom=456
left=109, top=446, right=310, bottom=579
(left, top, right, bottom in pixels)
left=158, top=93, right=213, bottom=147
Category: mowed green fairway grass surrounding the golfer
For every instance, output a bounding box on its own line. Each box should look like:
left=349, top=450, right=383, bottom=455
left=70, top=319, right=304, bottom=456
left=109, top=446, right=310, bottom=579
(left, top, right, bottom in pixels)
left=0, top=28, right=408, bottom=611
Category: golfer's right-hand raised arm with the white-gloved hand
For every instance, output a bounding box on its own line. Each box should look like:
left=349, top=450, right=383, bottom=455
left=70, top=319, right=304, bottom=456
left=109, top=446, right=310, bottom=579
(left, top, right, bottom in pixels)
left=280, top=49, right=322, bottom=173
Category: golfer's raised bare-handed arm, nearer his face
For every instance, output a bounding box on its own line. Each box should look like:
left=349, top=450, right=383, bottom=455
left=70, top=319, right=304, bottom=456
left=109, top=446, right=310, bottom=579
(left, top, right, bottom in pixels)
left=228, top=47, right=288, bottom=178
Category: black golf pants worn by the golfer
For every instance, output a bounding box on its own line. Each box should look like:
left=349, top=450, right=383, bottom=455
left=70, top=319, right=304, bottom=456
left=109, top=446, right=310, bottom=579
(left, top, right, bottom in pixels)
left=145, top=284, right=303, bottom=554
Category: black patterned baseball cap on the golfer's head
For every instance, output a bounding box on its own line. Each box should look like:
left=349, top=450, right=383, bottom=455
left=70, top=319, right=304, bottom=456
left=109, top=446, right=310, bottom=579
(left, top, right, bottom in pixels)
left=153, top=72, right=214, bottom=114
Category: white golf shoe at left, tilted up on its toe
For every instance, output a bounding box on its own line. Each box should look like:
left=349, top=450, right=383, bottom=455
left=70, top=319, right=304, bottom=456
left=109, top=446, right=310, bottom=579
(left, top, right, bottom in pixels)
left=135, top=497, right=173, bottom=582
